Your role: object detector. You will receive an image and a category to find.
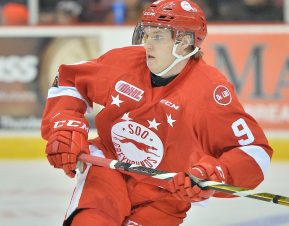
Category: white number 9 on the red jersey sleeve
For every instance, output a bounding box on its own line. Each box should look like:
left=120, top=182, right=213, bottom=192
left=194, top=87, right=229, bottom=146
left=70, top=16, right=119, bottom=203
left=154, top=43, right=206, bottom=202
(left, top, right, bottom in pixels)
left=232, top=118, right=255, bottom=146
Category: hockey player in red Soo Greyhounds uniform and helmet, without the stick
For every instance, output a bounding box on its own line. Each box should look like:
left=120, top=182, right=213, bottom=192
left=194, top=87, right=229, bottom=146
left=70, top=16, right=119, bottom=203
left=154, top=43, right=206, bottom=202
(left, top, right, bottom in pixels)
left=42, top=0, right=272, bottom=226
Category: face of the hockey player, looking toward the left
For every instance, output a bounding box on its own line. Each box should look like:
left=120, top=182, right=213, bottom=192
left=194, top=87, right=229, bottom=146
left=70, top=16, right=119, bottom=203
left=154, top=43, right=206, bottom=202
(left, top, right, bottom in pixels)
left=144, top=27, right=175, bottom=73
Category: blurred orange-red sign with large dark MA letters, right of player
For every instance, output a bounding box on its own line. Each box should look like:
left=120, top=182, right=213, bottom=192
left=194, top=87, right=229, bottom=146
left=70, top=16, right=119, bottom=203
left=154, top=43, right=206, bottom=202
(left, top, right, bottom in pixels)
left=203, top=32, right=289, bottom=131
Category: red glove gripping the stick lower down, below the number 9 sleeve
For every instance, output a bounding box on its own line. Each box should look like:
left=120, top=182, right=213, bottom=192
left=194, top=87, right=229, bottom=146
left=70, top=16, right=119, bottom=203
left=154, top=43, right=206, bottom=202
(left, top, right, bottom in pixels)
left=169, top=156, right=228, bottom=202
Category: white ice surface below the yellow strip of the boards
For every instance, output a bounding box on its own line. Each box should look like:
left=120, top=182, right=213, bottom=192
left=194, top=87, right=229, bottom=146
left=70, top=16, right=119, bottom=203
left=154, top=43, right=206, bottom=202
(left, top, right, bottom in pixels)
left=0, top=160, right=289, bottom=226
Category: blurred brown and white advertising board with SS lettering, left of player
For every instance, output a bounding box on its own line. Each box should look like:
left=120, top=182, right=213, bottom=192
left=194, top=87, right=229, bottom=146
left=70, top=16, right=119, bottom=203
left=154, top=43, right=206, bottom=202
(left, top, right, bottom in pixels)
left=0, top=26, right=133, bottom=132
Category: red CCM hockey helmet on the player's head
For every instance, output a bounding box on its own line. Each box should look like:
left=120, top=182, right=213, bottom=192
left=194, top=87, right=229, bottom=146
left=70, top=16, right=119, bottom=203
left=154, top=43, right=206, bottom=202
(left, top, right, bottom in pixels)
left=132, top=0, right=207, bottom=47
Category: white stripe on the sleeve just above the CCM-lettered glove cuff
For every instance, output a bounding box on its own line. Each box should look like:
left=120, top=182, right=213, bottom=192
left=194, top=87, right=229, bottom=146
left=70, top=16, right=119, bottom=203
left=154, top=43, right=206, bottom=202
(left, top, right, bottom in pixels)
left=47, top=86, right=92, bottom=113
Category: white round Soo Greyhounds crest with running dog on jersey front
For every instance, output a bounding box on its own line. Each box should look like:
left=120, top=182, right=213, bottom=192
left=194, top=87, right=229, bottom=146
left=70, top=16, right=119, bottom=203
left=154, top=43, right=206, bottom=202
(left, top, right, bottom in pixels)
left=111, top=121, right=164, bottom=169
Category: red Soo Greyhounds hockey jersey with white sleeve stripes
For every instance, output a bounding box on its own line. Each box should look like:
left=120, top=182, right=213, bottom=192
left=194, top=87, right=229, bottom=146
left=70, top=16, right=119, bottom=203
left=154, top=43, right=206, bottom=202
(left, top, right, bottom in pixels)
left=42, top=46, right=272, bottom=191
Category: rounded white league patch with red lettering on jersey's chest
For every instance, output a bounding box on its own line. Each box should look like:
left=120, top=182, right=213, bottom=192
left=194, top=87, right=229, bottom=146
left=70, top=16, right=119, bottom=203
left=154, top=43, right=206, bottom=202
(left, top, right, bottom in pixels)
left=115, top=81, right=144, bottom=101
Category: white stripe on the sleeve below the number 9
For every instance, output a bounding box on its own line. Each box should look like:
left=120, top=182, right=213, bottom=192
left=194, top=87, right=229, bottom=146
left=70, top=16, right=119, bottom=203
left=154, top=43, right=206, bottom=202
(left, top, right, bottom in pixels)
left=239, top=145, right=271, bottom=176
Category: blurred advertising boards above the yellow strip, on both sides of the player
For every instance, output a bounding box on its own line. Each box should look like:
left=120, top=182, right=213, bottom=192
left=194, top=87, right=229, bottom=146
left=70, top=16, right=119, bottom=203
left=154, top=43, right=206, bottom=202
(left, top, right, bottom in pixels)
left=0, top=25, right=289, bottom=132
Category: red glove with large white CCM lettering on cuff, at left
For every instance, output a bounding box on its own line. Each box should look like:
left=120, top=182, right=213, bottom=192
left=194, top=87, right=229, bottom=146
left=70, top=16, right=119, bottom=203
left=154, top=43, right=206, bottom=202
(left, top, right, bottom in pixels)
left=45, top=111, right=89, bottom=177
